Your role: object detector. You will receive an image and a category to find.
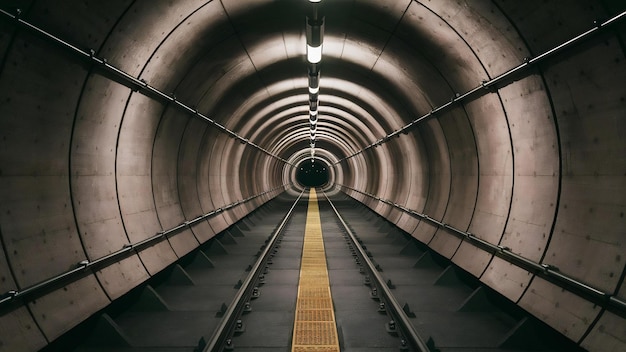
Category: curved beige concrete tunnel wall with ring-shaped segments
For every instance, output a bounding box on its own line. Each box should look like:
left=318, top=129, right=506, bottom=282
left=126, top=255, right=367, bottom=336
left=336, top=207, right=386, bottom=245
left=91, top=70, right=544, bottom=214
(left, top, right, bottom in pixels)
left=0, top=0, right=626, bottom=350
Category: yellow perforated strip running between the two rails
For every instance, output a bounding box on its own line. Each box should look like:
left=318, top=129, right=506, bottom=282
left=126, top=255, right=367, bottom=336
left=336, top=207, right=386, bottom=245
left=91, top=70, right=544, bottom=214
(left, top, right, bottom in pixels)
left=291, top=189, right=339, bottom=352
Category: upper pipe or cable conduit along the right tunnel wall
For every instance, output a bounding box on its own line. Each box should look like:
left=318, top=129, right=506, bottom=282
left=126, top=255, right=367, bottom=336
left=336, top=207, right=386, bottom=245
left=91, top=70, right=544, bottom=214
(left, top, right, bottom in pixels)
left=335, top=11, right=626, bottom=165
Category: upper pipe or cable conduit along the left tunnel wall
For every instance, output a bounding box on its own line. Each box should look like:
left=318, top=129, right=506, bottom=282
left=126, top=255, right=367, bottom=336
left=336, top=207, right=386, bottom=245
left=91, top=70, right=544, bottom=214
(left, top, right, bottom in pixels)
left=0, top=9, right=295, bottom=167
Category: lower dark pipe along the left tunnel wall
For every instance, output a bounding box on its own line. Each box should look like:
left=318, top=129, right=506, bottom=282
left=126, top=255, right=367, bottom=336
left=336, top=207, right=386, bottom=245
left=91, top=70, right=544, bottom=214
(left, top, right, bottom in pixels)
left=0, top=184, right=289, bottom=309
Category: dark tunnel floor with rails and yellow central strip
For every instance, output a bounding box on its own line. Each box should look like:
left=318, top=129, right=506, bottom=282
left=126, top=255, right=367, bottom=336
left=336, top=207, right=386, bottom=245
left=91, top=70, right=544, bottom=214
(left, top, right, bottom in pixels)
left=47, top=191, right=577, bottom=352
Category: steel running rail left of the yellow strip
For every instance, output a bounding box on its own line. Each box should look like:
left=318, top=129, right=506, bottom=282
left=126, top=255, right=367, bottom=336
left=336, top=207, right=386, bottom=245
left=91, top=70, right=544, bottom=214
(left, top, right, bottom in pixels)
left=202, top=190, right=304, bottom=352
